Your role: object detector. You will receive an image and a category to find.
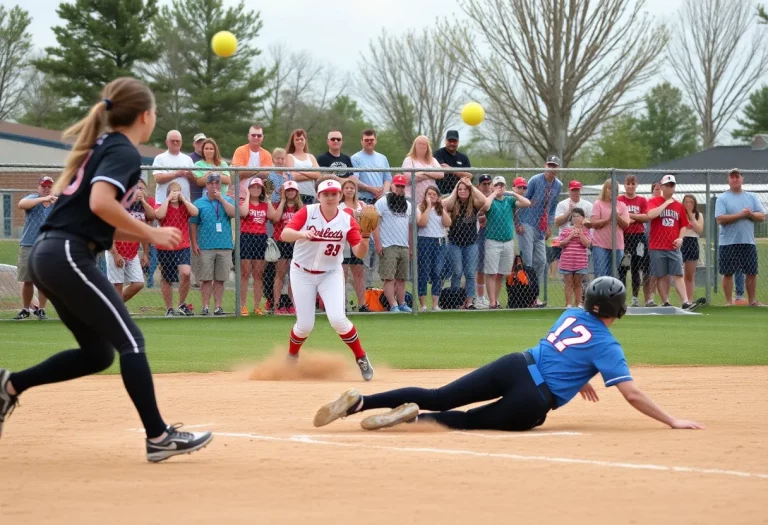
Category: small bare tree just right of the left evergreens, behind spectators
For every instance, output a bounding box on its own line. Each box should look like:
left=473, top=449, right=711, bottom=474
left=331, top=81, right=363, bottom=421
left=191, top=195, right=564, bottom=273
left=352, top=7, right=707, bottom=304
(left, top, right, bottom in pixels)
left=265, top=44, right=347, bottom=139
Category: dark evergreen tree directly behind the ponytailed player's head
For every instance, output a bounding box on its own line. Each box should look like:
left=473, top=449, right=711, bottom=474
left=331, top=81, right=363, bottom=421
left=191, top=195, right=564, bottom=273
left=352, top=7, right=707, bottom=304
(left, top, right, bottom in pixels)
left=35, top=0, right=159, bottom=128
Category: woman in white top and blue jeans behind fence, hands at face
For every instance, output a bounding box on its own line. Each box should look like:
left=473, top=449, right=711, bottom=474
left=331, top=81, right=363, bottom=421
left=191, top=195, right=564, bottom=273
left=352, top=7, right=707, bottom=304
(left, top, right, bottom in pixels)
left=416, top=186, right=451, bottom=312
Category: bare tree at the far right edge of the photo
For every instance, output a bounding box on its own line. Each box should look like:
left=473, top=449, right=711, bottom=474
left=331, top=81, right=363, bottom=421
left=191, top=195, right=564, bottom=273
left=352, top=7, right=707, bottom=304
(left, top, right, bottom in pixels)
left=669, top=0, right=768, bottom=148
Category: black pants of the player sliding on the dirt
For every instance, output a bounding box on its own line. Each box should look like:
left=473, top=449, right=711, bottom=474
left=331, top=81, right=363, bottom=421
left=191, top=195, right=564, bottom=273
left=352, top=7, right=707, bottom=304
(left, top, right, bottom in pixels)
left=362, top=353, right=554, bottom=430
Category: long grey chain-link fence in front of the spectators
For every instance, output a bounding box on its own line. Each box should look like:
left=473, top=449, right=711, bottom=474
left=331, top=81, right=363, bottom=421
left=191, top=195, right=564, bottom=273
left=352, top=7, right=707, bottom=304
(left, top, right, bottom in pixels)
left=0, top=164, right=768, bottom=319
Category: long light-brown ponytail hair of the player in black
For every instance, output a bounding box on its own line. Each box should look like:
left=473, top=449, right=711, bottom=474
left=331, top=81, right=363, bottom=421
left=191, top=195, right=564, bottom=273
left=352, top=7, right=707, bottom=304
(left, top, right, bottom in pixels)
left=53, top=77, right=155, bottom=194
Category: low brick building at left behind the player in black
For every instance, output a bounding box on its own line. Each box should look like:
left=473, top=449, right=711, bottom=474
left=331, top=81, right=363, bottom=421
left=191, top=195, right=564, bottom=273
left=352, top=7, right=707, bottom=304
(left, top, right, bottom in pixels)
left=0, top=121, right=165, bottom=238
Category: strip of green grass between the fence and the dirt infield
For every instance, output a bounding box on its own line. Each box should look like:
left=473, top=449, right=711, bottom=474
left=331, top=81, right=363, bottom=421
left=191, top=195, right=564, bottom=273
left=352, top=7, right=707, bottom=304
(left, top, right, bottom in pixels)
left=0, top=307, right=768, bottom=373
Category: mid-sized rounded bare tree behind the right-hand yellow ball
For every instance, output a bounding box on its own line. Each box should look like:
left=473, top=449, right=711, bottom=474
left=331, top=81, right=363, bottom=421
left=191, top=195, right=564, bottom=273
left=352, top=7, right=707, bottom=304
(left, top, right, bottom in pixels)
left=358, top=31, right=462, bottom=147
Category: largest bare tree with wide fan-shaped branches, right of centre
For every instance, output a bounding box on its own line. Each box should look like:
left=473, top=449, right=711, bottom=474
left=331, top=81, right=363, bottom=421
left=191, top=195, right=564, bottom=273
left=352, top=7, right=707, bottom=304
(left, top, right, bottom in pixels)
left=440, top=0, right=669, bottom=164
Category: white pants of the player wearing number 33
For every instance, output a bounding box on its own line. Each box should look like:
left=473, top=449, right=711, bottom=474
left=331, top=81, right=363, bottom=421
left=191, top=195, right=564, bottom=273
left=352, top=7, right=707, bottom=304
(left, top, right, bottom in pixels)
left=291, top=262, right=353, bottom=338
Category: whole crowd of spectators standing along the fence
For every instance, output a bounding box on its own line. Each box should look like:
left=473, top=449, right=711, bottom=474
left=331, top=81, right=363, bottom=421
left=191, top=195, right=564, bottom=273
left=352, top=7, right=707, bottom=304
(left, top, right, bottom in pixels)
left=9, top=124, right=765, bottom=319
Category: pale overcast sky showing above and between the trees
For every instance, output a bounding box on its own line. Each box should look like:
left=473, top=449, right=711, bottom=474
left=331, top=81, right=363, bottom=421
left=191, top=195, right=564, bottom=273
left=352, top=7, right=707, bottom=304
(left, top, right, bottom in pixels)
left=9, top=0, right=756, bottom=143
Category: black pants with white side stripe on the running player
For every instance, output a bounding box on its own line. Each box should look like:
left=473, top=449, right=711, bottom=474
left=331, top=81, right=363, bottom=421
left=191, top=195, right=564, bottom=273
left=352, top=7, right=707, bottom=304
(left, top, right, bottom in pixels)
left=10, top=232, right=166, bottom=438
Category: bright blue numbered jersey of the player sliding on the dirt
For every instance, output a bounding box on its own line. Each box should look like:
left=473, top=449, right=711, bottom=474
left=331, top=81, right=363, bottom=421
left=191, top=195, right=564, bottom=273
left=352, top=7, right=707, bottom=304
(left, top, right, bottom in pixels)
left=531, top=308, right=632, bottom=407
